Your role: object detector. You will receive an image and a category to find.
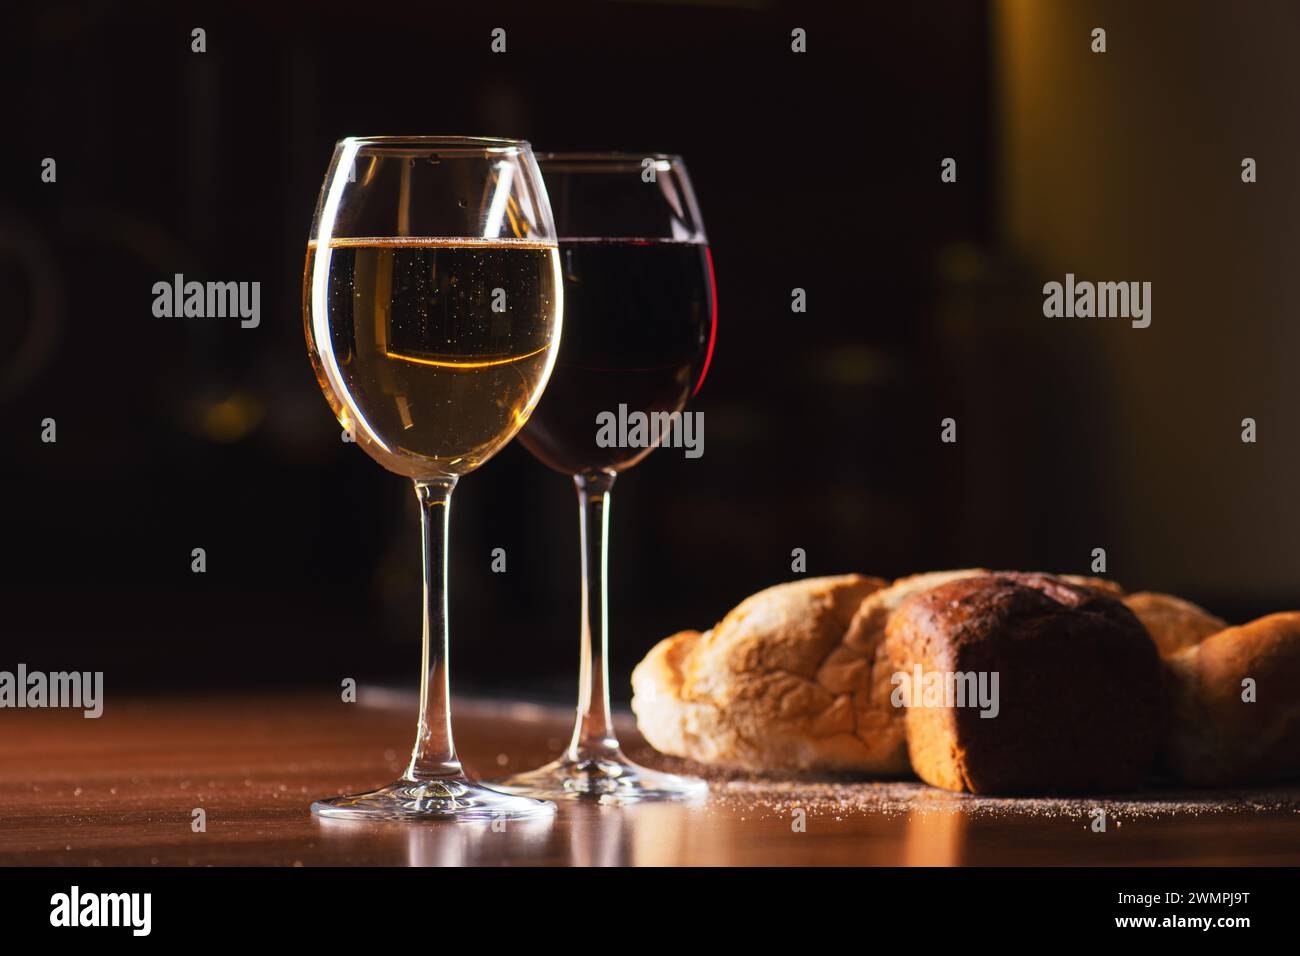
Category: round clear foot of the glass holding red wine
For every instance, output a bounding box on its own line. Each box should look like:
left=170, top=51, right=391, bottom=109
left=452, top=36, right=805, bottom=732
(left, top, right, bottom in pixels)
left=491, top=750, right=709, bottom=804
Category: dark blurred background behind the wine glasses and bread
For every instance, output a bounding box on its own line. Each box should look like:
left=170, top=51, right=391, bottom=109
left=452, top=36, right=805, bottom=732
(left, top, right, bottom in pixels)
left=0, top=0, right=1300, bottom=698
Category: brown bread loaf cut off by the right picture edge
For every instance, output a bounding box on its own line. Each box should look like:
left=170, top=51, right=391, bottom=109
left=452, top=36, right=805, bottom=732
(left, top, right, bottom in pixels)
left=1164, top=611, right=1300, bottom=786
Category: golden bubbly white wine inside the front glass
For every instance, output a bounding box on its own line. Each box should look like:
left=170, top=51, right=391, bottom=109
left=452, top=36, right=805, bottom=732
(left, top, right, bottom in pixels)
left=303, top=237, right=563, bottom=479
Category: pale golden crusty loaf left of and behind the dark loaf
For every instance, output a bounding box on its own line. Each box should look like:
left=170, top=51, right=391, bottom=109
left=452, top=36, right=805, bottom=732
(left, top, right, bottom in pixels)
left=632, top=568, right=1133, bottom=777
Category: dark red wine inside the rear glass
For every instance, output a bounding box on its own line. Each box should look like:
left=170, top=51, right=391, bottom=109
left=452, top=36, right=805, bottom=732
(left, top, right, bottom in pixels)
left=519, top=239, right=714, bottom=475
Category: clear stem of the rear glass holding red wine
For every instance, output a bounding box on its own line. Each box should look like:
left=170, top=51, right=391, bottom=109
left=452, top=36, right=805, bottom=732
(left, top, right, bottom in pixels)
left=564, top=472, right=619, bottom=761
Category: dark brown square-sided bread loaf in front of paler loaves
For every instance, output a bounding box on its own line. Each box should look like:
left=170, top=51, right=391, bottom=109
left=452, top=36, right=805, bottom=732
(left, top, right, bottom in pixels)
left=885, top=574, right=1162, bottom=793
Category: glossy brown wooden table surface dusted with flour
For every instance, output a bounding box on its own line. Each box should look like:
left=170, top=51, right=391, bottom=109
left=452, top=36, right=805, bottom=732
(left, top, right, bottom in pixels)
left=0, top=688, right=1300, bottom=866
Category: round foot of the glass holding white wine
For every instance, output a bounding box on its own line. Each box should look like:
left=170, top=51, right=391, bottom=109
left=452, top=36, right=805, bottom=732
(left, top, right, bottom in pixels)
left=312, top=777, right=555, bottom=822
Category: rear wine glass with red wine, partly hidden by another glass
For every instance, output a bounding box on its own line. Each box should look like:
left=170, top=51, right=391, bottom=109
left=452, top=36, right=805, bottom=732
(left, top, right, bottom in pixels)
left=493, top=153, right=716, bottom=803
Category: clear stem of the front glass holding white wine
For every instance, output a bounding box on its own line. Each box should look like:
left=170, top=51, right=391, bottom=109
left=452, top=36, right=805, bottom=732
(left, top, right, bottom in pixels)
left=406, top=476, right=463, bottom=780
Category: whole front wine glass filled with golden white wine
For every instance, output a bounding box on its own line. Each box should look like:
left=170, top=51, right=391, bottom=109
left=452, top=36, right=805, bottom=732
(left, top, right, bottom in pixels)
left=303, top=137, right=563, bottom=821
